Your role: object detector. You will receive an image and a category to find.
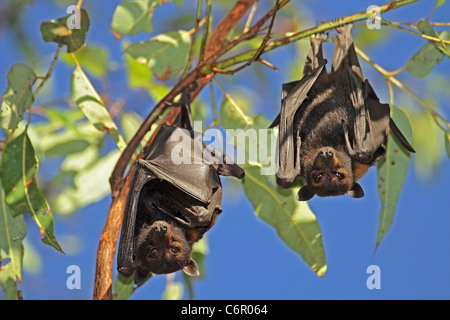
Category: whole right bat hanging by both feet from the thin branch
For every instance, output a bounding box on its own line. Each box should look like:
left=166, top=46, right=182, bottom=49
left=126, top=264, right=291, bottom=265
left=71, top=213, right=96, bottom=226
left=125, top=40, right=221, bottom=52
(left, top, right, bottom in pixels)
left=271, top=24, right=415, bottom=201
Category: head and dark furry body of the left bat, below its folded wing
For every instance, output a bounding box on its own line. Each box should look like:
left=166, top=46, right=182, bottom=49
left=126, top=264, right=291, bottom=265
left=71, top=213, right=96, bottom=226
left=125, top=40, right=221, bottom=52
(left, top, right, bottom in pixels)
left=134, top=179, right=221, bottom=282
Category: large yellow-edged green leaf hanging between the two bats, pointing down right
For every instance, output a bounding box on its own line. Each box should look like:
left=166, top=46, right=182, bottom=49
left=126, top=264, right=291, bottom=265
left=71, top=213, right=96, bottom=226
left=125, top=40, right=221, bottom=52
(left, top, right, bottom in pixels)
left=221, top=107, right=327, bottom=276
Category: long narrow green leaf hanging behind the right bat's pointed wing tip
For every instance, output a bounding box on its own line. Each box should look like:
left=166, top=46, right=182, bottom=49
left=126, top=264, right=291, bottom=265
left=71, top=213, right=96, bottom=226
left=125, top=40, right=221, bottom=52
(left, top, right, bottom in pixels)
left=377, top=106, right=412, bottom=246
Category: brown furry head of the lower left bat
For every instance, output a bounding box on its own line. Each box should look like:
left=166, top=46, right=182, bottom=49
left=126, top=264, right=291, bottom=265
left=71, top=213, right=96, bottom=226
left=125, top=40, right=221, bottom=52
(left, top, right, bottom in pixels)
left=135, top=220, right=199, bottom=282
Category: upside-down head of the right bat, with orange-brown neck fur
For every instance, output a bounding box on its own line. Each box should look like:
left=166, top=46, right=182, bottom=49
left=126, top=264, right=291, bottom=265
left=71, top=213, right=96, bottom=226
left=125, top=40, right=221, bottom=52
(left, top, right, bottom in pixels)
left=297, top=147, right=364, bottom=201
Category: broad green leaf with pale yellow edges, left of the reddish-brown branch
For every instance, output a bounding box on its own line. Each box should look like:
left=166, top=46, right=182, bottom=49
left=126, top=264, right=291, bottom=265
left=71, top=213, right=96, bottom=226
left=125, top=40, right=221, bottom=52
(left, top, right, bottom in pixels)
left=125, top=30, right=191, bottom=80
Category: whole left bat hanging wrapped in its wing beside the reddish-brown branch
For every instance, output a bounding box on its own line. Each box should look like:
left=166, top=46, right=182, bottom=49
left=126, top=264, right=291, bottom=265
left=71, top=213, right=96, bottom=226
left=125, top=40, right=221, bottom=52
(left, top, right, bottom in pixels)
left=117, top=84, right=244, bottom=283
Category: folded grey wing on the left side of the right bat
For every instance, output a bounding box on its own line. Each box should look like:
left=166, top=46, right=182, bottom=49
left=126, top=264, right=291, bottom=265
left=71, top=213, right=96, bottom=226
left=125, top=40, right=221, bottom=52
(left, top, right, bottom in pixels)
left=276, top=60, right=326, bottom=188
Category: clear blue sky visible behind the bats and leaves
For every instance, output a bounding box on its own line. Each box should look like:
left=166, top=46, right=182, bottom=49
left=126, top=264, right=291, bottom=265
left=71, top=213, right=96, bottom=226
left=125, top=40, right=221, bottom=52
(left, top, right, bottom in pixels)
left=0, top=0, right=450, bottom=299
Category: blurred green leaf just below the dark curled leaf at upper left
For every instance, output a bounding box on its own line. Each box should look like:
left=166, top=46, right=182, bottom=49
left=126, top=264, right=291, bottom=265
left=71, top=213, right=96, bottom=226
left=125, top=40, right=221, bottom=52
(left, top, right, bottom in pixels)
left=62, top=45, right=108, bottom=78
